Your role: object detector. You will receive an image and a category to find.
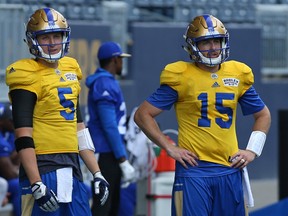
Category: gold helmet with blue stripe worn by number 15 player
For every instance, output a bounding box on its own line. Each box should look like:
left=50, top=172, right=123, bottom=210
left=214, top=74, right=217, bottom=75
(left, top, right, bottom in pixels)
left=183, top=14, right=230, bottom=67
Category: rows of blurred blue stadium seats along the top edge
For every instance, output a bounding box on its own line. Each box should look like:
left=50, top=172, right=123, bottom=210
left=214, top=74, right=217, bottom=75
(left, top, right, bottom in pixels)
left=0, top=0, right=288, bottom=23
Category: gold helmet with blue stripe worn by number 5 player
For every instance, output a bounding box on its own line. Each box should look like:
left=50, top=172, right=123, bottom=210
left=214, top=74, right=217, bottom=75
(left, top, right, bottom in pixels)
left=26, top=8, right=71, bottom=62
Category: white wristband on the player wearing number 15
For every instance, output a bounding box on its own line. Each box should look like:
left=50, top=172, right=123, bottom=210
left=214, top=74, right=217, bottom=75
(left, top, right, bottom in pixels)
left=246, top=131, right=266, bottom=157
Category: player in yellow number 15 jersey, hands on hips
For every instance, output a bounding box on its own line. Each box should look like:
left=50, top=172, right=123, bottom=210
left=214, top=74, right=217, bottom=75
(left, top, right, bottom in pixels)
left=134, top=14, right=271, bottom=216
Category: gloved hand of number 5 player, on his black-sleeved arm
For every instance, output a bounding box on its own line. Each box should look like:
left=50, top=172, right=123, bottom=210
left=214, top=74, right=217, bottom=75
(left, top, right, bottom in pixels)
left=31, top=182, right=59, bottom=212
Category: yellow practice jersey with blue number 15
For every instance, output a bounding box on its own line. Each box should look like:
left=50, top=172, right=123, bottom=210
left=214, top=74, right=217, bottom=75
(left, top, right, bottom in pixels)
left=160, top=61, right=254, bottom=165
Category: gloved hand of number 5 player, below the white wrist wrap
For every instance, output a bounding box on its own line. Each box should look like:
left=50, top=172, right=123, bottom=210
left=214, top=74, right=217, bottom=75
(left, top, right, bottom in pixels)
left=94, top=171, right=109, bottom=206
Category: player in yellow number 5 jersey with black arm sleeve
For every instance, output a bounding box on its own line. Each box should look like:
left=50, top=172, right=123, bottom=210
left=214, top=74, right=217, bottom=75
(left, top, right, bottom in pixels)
left=6, top=8, right=109, bottom=216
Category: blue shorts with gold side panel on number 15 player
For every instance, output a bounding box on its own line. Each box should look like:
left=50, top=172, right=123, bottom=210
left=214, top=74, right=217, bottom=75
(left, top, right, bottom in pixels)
left=171, top=164, right=245, bottom=216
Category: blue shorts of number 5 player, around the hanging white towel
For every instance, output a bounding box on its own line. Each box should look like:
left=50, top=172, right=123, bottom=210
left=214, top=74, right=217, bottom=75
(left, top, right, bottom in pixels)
left=20, top=171, right=91, bottom=216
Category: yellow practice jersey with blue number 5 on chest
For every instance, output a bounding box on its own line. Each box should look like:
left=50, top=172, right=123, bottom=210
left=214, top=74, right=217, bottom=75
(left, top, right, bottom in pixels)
left=6, top=57, right=82, bottom=154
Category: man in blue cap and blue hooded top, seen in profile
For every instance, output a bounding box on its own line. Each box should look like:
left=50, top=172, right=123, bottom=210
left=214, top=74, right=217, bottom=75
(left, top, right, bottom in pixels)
left=86, top=41, right=135, bottom=216
